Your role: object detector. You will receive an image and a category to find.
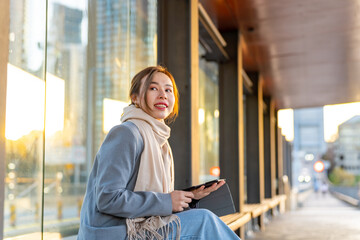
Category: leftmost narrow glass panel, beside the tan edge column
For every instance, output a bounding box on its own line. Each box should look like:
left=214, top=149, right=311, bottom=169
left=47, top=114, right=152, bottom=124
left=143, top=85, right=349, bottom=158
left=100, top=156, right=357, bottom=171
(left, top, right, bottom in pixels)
left=4, top=0, right=46, bottom=239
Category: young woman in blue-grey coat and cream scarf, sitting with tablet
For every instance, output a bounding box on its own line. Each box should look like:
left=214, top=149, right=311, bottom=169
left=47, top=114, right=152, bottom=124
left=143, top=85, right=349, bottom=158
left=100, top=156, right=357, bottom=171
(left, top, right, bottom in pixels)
left=78, top=66, right=239, bottom=240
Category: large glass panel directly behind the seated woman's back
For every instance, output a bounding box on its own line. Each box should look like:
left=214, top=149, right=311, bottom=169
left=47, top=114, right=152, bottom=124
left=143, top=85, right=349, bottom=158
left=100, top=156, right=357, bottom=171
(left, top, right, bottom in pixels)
left=44, top=0, right=157, bottom=239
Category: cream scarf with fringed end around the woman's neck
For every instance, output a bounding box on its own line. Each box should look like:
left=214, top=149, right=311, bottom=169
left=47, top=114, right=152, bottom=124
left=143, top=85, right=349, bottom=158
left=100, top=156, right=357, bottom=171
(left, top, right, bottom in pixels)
left=121, top=105, right=181, bottom=240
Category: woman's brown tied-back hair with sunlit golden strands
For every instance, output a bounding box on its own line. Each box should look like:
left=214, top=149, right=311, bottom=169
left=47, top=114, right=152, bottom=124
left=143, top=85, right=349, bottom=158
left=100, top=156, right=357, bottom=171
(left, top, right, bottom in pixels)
left=130, top=66, right=179, bottom=123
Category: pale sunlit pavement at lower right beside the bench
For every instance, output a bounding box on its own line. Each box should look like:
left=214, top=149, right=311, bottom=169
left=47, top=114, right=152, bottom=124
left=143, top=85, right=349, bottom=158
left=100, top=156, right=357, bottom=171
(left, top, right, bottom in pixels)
left=248, top=190, right=360, bottom=240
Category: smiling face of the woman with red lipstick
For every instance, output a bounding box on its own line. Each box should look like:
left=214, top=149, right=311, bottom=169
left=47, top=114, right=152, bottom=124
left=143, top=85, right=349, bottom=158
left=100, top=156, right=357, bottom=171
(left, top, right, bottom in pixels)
left=139, top=72, right=175, bottom=120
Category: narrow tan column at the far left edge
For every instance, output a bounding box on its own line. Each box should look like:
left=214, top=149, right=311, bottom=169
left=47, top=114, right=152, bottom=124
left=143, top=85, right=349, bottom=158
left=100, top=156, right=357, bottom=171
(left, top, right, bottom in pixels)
left=0, top=0, right=10, bottom=239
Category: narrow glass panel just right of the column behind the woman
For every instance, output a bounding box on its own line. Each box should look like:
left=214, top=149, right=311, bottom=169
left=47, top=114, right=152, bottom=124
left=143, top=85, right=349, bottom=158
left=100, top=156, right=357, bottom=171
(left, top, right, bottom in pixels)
left=199, top=45, right=220, bottom=182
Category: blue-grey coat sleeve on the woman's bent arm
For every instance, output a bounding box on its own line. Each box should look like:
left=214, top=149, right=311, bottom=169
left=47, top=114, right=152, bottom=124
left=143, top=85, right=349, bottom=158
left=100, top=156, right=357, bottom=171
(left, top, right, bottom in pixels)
left=95, top=124, right=172, bottom=218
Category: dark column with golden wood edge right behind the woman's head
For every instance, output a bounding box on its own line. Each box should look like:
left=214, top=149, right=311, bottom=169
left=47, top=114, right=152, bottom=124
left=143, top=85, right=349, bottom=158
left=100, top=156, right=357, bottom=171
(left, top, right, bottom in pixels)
left=158, top=0, right=200, bottom=189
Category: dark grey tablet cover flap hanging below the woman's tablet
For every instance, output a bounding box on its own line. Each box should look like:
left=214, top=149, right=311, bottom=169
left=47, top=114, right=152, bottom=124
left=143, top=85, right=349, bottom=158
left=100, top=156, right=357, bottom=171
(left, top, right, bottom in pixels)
left=190, top=183, right=236, bottom=217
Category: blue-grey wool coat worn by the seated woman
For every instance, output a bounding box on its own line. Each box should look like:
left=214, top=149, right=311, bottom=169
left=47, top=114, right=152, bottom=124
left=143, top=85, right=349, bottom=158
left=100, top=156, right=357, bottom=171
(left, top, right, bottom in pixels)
left=77, top=122, right=172, bottom=240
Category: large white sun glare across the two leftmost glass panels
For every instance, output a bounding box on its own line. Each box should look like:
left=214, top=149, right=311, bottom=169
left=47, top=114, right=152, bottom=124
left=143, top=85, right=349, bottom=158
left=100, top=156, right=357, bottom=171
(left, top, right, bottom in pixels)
left=5, top=64, right=65, bottom=141
